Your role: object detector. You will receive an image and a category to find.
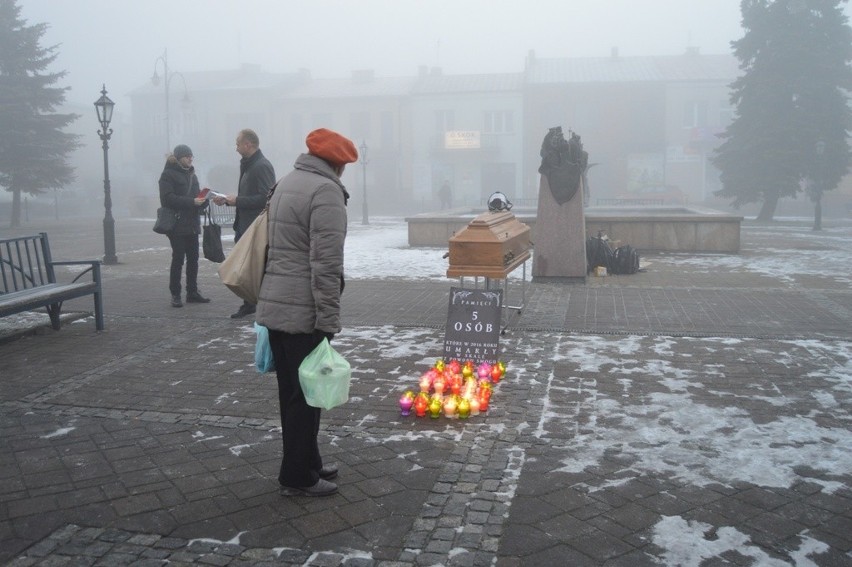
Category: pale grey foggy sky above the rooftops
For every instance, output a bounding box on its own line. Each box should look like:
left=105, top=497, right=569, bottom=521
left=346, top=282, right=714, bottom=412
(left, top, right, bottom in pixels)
left=20, top=0, right=742, bottom=110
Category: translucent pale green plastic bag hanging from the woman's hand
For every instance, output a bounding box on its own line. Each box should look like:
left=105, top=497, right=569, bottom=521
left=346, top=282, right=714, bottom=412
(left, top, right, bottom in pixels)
left=299, top=338, right=352, bottom=410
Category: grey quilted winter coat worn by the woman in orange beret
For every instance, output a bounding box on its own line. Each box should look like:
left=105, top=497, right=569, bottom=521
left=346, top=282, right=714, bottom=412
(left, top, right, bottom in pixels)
left=256, top=154, right=349, bottom=333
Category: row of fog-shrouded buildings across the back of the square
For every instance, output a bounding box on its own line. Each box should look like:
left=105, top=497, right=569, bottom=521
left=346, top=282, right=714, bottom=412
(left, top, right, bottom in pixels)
left=131, top=50, right=752, bottom=218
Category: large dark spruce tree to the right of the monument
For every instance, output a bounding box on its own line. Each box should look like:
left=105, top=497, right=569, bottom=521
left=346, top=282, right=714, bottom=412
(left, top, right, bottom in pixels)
left=713, top=0, right=852, bottom=220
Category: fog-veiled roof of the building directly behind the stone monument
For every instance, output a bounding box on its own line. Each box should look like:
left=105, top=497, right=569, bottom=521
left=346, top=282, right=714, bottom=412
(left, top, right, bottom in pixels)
left=526, top=52, right=739, bottom=84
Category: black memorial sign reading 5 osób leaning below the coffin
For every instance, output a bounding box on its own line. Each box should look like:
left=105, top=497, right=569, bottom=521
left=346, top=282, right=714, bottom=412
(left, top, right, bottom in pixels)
left=444, top=287, right=503, bottom=364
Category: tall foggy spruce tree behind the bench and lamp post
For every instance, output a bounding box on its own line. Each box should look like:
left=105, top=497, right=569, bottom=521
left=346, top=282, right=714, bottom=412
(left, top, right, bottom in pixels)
left=0, top=0, right=79, bottom=227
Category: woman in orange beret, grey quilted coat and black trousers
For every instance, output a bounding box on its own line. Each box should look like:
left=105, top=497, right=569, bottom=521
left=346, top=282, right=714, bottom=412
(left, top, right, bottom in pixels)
left=257, top=128, right=358, bottom=496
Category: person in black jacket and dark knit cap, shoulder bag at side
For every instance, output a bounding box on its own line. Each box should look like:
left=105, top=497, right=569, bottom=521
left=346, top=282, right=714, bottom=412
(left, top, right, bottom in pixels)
left=160, top=144, right=210, bottom=307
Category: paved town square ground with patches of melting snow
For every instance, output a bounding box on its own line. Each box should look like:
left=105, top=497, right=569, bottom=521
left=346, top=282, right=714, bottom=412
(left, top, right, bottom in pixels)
left=0, top=216, right=852, bottom=567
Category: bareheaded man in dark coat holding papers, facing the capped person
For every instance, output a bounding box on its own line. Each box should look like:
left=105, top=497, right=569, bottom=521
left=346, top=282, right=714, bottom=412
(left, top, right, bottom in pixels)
left=213, top=128, right=275, bottom=319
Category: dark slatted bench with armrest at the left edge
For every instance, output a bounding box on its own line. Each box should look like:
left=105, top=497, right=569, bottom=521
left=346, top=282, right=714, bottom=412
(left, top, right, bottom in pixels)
left=0, top=232, right=104, bottom=331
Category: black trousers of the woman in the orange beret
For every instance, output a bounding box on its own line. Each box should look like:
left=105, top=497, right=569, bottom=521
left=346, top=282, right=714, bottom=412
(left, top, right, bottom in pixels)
left=269, top=329, right=323, bottom=488
